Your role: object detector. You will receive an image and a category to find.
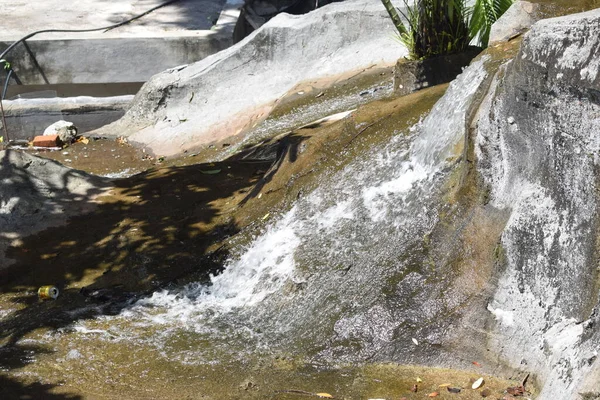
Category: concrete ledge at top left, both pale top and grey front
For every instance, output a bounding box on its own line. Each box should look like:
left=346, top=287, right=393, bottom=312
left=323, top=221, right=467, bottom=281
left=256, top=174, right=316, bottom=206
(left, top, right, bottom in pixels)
left=0, top=0, right=241, bottom=85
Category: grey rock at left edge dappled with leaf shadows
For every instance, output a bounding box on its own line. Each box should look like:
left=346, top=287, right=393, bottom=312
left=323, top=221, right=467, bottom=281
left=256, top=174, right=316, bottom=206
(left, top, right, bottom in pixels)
left=0, top=150, right=110, bottom=270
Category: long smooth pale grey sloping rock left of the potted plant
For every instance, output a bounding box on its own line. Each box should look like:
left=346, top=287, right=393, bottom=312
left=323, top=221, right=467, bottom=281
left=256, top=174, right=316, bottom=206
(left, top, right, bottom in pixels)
left=100, top=0, right=407, bottom=155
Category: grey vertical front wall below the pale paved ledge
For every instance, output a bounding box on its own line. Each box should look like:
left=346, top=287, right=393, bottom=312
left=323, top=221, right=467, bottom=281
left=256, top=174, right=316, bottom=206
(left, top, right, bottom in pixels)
left=0, top=32, right=231, bottom=85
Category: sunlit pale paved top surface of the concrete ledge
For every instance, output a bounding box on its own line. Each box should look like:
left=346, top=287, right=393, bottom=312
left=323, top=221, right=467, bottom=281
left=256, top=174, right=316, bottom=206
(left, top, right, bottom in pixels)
left=0, top=0, right=225, bottom=41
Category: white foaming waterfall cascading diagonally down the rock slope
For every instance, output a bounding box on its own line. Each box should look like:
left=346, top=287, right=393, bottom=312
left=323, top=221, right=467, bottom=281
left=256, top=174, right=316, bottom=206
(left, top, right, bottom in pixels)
left=90, top=59, right=487, bottom=366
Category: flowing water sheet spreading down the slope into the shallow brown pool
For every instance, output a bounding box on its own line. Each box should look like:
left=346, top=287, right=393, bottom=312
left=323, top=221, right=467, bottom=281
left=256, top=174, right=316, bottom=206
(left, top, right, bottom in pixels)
left=67, top=59, right=487, bottom=363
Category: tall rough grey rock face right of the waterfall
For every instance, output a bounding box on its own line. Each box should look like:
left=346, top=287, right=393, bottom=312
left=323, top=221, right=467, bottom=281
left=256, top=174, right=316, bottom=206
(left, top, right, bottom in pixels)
left=477, top=9, right=600, bottom=400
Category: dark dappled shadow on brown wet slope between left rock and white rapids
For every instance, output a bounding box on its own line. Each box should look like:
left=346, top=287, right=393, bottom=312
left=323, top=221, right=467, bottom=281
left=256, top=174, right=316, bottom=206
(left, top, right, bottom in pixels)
left=0, top=148, right=271, bottom=345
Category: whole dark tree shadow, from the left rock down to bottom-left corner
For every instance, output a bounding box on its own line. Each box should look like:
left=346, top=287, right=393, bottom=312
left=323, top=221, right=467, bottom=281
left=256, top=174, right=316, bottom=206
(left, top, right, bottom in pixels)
left=0, top=130, right=306, bottom=399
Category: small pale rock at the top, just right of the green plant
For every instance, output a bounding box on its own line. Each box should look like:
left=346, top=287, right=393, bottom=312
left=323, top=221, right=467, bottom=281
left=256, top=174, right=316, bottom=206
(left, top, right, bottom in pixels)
left=489, top=1, right=540, bottom=44
